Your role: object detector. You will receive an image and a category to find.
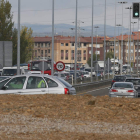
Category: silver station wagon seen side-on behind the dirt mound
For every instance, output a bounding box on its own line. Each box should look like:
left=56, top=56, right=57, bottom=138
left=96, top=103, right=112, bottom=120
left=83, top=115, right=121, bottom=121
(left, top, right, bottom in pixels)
left=0, top=74, right=76, bottom=95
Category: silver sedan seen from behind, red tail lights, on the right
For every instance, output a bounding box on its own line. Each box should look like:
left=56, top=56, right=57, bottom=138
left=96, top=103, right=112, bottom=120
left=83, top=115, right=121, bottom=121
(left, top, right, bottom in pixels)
left=109, top=82, right=138, bottom=98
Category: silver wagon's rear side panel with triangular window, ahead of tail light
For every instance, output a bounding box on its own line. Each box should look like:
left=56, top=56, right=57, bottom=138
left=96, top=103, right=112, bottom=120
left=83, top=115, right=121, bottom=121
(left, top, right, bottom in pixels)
left=44, top=77, right=64, bottom=94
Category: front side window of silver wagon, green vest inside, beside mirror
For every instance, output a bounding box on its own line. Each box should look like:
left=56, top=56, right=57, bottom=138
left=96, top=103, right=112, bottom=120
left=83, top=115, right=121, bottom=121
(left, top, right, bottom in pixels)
left=5, top=76, right=26, bottom=90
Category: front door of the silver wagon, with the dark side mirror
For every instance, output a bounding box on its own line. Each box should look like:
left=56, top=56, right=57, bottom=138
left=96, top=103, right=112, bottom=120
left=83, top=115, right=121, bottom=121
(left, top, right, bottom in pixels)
left=0, top=76, right=26, bottom=94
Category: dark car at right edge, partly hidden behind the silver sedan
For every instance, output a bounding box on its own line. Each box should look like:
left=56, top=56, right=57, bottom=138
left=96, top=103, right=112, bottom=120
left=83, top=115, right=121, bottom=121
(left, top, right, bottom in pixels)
left=125, top=77, right=140, bottom=97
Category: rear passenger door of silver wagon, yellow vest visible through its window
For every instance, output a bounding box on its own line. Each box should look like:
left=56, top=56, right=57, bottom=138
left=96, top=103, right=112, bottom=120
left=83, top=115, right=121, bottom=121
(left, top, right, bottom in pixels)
left=21, top=76, right=49, bottom=94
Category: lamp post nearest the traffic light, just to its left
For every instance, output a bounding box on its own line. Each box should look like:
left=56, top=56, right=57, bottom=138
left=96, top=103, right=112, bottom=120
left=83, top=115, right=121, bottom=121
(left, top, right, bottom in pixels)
left=125, top=7, right=132, bottom=74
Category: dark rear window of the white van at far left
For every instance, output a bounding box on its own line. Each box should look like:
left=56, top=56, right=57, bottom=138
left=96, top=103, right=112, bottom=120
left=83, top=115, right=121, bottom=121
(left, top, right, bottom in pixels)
left=2, top=69, right=21, bottom=76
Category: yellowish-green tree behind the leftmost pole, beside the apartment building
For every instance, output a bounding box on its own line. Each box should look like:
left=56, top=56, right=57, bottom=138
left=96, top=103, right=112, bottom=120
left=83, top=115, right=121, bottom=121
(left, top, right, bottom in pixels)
left=12, top=26, right=33, bottom=65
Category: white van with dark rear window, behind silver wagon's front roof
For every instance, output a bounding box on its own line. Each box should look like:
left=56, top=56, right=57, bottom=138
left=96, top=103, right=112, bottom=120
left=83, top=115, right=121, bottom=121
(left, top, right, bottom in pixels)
left=2, top=67, right=25, bottom=76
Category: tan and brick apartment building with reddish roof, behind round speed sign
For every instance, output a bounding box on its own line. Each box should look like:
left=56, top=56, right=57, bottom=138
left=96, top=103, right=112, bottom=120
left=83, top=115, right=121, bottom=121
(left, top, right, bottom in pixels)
left=34, top=36, right=103, bottom=64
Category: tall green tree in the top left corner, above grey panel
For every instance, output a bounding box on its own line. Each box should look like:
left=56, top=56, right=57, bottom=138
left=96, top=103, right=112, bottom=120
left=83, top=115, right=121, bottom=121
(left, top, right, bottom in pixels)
left=0, top=0, right=14, bottom=41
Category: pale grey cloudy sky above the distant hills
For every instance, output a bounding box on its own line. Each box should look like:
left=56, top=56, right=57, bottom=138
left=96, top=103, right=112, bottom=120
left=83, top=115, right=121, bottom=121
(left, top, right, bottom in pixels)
left=9, top=0, right=140, bottom=36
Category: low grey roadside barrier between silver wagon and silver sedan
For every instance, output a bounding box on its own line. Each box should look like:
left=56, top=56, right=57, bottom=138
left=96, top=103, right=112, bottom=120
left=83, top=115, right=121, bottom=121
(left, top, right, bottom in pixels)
left=73, top=79, right=112, bottom=93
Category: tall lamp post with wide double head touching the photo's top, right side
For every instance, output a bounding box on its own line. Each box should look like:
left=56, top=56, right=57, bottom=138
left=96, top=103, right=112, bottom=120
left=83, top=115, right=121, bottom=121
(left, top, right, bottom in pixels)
left=118, top=1, right=127, bottom=75
